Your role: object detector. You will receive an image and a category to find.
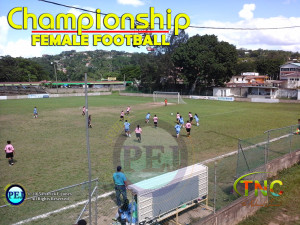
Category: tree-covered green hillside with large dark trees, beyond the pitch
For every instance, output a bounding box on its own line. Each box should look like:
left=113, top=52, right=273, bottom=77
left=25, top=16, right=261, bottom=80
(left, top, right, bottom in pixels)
left=0, top=31, right=300, bottom=93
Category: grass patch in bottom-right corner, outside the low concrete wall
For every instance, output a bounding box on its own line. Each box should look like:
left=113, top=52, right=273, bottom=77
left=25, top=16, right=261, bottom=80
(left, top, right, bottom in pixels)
left=239, top=164, right=300, bottom=225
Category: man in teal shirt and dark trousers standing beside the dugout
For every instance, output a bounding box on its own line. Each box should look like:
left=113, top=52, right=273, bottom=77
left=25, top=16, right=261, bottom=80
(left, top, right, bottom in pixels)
left=113, top=166, right=127, bottom=207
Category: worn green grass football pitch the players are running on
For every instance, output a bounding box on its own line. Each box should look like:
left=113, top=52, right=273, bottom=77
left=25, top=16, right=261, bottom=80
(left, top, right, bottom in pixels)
left=0, top=95, right=300, bottom=224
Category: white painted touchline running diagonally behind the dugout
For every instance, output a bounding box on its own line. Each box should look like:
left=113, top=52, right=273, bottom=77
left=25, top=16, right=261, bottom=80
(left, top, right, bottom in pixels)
left=12, top=134, right=292, bottom=225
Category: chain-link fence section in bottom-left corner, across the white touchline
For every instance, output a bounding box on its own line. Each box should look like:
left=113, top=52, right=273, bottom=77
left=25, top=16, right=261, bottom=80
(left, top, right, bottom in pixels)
left=0, top=179, right=98, bottom=225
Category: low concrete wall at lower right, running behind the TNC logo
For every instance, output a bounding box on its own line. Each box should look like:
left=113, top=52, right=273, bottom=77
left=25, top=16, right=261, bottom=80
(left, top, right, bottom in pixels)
left=193, top=149, right=300, bottom=225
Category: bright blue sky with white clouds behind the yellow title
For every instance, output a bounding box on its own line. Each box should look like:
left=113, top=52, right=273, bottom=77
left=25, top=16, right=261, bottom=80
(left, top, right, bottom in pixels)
left=0, top=0, right=300, bottom=58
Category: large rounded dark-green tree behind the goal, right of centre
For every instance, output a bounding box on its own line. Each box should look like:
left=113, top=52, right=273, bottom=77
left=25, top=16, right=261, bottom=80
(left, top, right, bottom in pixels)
left=172, top=35, right=237, bottom=92
